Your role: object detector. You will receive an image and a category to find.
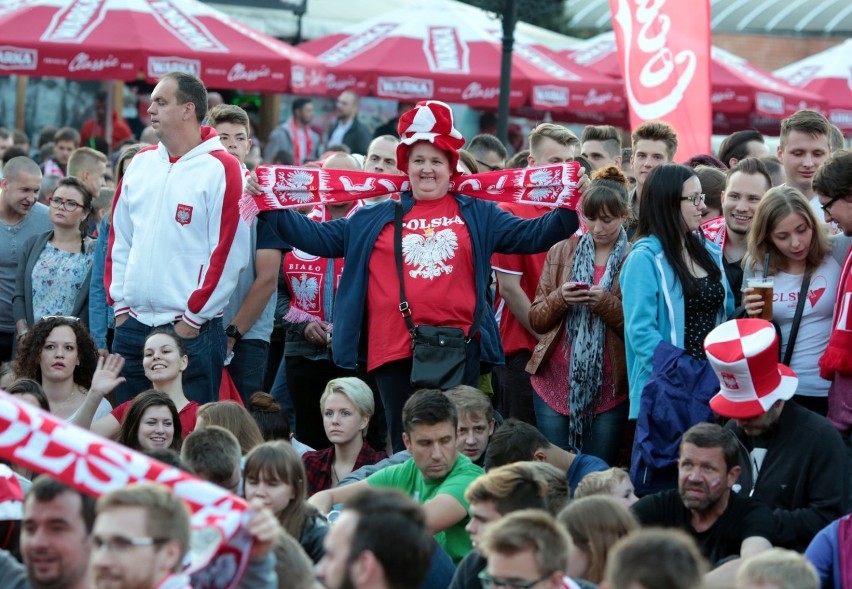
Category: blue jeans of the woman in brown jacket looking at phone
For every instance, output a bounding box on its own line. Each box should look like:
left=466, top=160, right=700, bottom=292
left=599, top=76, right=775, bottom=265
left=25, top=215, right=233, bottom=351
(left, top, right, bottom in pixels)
left=533, top=395, right=630, bottom=464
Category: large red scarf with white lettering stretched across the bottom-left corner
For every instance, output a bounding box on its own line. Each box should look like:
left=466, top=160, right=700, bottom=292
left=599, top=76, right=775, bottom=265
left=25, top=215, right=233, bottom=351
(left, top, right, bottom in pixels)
left=0, top=392, right=252, bottom=589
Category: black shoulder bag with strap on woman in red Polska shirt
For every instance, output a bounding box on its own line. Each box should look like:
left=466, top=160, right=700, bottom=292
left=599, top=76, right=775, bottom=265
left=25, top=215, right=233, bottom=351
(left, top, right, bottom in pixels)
left=394, top=203, right=481, bottom=389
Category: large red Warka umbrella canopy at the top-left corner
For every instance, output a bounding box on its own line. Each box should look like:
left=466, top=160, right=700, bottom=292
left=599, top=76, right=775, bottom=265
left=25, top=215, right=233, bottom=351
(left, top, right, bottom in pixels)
left=0, top=0, right=325, bottom=94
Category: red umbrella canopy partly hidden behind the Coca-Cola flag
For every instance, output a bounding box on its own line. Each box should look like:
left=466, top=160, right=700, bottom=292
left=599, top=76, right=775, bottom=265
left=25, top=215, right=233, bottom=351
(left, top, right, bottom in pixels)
left=565, top=32, right=824, bottom=119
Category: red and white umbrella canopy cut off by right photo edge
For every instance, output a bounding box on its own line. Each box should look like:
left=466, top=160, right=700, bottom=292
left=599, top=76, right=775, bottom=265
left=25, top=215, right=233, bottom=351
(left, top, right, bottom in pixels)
left=773, top=39, right=852, bottom=133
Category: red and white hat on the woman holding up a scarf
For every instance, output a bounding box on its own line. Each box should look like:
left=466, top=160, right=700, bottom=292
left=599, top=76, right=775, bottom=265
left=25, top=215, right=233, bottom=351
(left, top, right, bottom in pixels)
left=396, top=100, right=465, bottom=176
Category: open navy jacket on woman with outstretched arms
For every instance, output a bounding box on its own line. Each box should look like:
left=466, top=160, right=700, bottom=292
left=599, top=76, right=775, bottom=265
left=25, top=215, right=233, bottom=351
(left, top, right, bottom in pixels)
left=263, top=192, right=578, bottom=369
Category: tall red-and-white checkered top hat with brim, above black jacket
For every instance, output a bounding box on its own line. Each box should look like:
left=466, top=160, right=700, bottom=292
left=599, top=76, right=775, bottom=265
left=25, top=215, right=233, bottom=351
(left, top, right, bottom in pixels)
left=704, top=319, right=799, bottom=419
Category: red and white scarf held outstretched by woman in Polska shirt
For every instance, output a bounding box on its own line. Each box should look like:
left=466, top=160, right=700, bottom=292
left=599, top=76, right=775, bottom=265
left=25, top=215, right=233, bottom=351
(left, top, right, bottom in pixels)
left=240, top=162, right=580, bottom=220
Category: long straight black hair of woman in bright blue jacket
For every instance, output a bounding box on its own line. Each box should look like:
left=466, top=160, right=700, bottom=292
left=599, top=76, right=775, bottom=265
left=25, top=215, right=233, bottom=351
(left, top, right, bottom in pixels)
left=633, top=164, right=722, bottom=297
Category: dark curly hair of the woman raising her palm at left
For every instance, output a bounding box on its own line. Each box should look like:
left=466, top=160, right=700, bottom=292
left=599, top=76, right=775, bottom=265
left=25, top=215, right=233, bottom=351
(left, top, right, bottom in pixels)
left=15, top=317, right=98, bottom=389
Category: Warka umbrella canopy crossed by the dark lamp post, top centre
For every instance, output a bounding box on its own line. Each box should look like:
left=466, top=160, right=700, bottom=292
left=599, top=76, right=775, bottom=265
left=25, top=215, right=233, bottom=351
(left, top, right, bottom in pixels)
left=299, top=0, right=623, bottom=111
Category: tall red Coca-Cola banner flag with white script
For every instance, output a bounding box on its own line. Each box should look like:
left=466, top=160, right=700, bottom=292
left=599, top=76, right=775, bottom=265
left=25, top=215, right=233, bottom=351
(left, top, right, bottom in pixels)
left=609, top=0, right=712, bottom=161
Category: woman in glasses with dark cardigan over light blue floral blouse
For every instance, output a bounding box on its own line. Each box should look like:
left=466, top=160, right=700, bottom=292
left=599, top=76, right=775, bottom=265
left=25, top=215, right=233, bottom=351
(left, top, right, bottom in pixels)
left=12, top=176, right=94, bottom=338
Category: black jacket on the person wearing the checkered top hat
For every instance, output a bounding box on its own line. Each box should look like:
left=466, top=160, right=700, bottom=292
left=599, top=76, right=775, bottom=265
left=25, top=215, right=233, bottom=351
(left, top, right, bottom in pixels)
left=726, top=401, right=848, bottom=552
